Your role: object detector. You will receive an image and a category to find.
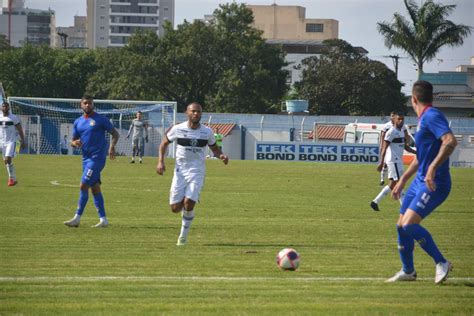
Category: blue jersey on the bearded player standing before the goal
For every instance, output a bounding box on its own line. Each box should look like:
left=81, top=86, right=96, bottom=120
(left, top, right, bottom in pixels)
left=72, top=112, right=114, bottom=161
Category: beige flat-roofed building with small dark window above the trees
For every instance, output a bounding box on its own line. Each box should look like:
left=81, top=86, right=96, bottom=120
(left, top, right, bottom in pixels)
left=247, top=4, right=339, bottom=41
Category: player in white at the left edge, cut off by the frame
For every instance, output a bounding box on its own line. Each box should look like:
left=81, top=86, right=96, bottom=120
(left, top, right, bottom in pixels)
left=0, top=101, right=25, bottom=186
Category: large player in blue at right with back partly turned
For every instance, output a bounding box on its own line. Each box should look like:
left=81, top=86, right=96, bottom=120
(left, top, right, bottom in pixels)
left=387, top=81, right=457, bottom=284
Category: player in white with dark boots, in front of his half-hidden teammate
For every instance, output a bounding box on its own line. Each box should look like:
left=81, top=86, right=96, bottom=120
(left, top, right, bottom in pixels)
left=370, top=113, right=416, bottom=211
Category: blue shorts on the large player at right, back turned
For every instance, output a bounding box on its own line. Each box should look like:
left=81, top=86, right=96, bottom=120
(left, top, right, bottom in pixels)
left=400, top=178, right=451, bottom=218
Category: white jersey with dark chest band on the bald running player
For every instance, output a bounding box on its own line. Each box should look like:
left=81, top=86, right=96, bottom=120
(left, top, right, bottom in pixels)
left=166, top=121, right=216, bottom=174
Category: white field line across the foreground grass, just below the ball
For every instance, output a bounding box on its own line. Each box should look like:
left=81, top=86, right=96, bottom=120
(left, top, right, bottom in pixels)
left=0, top=276, right=474, bottom=282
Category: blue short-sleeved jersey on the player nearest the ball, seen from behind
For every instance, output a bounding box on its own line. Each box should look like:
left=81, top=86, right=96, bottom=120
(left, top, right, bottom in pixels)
left=415, top=107, right=451, bottom=185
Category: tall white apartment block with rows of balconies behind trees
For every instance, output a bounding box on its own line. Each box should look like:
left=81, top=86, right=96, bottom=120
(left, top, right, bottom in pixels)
left=87, top=0, right=175, bottom=48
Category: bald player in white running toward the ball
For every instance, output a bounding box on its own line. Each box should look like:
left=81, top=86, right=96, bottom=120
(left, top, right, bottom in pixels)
left=156, top=103, right=229, bottom=246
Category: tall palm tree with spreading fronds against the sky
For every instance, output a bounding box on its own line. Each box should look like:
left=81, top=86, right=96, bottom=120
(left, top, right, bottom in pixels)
left=377, top=0, right=471, bottom=76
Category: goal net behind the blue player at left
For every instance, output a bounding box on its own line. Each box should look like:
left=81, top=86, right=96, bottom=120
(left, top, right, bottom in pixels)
left=8, top=97, right=176, bottom=156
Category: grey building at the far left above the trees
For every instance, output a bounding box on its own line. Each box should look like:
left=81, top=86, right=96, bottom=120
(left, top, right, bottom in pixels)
left=0, top=0, right=56, bottom=47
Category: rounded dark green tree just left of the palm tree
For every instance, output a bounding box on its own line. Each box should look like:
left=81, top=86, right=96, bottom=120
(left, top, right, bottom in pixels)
left=295, top=40, right=406, bottom=115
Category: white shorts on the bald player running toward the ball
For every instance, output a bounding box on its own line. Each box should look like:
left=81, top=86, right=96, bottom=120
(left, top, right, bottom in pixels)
left=170, top=167, right=204, bottom=205
